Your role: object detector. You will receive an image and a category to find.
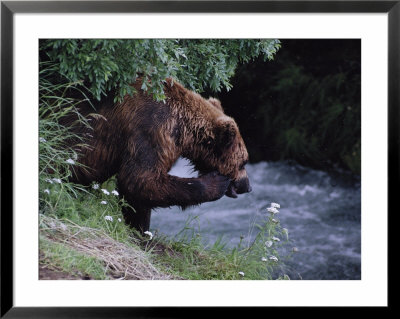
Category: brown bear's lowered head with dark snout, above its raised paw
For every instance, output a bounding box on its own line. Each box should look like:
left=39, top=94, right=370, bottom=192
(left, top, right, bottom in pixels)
left=192, top=111, right=251, bottom=198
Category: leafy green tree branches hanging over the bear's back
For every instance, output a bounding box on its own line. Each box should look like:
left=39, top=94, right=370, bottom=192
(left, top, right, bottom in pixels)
left=39, top=39, right=280, bottom=100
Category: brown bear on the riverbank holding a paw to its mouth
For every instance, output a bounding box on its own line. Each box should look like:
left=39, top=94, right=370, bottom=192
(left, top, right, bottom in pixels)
left=73, top=79, right=251, bottom=232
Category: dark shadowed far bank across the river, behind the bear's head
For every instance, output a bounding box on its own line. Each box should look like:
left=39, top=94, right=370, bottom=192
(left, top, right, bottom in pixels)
left=204, top=39, right=361, bottom=175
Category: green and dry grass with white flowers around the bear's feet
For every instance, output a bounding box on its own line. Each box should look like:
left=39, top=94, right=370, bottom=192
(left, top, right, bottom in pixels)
left=39, top=63, right=296, bottom=280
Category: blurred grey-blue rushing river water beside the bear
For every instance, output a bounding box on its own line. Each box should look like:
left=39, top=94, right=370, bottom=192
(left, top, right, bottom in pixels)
left=150, top=159, right=361, bottom=280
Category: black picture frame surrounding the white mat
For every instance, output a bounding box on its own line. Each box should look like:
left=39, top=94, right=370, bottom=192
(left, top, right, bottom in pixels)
left=0, top=0, right=394, bottom=318
